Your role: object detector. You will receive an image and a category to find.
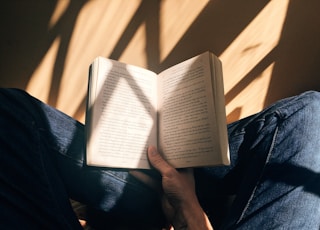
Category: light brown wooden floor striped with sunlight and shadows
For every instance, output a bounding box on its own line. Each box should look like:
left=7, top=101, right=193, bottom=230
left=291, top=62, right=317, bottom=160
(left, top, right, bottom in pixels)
left=0, top=0, right=320, bottom=122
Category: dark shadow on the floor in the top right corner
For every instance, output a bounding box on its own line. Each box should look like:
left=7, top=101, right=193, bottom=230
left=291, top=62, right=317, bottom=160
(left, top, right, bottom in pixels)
left=264, top=0, right=320, bottom=106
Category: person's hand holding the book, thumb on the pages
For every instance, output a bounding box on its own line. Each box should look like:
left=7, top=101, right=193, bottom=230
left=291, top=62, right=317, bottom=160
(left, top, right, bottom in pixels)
left=148, top=146, right=212, bottom=229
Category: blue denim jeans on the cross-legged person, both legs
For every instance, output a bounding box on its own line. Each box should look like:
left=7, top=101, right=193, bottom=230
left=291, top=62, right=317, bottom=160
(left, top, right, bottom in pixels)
left=0, top=89, right=320, bottom=230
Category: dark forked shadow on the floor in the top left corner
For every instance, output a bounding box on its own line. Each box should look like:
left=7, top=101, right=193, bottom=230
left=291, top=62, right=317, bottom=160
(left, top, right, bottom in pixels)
left=0, top=0, right=87, bottom=106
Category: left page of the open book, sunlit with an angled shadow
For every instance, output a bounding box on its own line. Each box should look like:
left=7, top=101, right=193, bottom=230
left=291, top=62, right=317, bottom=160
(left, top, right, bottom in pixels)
left=87, top=59, right=157, bottom=168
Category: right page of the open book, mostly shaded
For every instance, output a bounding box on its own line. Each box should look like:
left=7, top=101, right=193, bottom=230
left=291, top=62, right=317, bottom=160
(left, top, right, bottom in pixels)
left=158, top=53, right=221, bottom=167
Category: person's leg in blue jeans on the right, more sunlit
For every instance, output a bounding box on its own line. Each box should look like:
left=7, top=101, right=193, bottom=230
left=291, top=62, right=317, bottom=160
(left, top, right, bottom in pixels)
left=196, top=92, right=320, bottom=229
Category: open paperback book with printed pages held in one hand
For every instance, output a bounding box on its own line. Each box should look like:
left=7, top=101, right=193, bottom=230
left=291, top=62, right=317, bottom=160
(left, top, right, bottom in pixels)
left=86, top=52, right=229, bottom=169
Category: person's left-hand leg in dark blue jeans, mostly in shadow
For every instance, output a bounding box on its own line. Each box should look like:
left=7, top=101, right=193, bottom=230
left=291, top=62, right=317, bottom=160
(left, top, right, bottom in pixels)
left=0, top=89, right=163, bottom=227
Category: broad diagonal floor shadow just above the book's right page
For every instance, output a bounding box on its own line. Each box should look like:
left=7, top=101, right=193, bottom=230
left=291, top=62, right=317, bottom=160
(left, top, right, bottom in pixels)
left=157, top=0, right=269, bottom=71
